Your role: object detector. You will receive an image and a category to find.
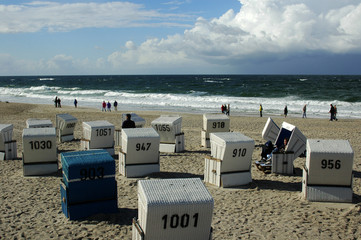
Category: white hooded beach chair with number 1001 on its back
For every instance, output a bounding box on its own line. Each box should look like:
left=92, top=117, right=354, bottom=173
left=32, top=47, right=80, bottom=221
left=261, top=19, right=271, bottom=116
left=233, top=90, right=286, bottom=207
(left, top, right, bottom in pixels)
left=132, top=178, right=214, bottom=240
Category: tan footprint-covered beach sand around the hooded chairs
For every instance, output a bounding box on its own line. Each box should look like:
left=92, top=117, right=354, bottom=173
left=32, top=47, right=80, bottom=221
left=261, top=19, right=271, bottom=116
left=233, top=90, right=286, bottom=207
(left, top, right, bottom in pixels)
left=0, top=102, right=361, bottom=239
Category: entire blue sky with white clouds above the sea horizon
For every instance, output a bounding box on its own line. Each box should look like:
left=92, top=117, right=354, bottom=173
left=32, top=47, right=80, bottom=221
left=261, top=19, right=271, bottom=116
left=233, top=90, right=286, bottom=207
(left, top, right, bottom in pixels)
left=0, top=0, right=361, bottom=76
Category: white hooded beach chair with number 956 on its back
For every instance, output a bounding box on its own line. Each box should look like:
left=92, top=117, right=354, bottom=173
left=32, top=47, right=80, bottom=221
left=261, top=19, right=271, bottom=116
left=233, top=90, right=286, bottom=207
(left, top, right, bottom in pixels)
left=302, top=139, right=354, bottom=202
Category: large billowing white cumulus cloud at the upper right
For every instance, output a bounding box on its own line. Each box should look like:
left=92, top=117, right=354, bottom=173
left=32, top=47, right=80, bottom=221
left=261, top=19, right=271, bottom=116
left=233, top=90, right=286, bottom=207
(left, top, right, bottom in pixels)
left=108, top=0, right=361, bottom=72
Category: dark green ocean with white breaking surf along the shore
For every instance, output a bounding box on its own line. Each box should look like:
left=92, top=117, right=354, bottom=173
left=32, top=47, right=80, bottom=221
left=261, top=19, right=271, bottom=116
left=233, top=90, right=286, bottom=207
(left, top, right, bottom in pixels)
left=0, top=75, right=361, bottom=118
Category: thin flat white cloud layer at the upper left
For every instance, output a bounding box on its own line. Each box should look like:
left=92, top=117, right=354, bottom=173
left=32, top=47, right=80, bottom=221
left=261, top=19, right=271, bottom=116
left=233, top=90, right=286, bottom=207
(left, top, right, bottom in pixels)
left=0, top=1, right=191, bottom=33
